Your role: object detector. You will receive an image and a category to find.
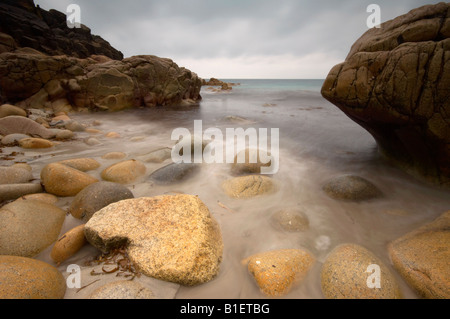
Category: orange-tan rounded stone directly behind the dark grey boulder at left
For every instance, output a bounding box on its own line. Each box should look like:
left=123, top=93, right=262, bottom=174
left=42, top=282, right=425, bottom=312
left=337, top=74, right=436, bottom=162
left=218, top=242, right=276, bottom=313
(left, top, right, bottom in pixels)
left=41, top=163, right=98, bottom=197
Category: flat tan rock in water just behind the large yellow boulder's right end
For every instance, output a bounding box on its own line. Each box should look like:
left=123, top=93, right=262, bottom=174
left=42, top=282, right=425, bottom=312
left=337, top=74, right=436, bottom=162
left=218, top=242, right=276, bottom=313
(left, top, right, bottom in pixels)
left=222, top=175, right=275, bottom=199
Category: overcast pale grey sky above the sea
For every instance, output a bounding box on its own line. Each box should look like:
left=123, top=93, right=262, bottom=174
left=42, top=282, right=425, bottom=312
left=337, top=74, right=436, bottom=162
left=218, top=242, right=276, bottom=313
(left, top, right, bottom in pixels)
left=35, top=0, right=440, bottom=79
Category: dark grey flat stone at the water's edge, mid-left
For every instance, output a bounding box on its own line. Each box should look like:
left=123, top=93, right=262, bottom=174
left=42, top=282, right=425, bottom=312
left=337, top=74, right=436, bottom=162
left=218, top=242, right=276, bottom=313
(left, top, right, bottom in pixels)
left=150, top=163, right=200, bottom=185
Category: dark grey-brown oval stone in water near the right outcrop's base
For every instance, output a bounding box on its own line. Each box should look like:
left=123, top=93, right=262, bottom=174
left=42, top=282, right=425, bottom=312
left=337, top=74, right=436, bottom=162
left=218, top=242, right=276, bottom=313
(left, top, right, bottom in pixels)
left=323, top=175, right=382, bottom=201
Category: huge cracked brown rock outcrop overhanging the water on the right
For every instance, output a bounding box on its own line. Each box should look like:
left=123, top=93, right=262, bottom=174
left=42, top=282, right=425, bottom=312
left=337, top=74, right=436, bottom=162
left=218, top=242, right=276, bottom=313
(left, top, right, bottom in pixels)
left=322, top=2, right=450, bottom=186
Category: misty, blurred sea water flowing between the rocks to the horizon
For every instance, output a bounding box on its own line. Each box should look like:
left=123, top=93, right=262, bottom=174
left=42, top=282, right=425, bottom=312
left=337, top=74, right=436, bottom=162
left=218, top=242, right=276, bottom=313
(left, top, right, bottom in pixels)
left=26, top=79, right=450, bottom=299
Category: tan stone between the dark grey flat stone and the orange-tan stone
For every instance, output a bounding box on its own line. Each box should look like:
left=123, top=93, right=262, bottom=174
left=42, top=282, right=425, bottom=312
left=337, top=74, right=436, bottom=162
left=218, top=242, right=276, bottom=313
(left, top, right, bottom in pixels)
left=101, top=160, right=147, bottom=184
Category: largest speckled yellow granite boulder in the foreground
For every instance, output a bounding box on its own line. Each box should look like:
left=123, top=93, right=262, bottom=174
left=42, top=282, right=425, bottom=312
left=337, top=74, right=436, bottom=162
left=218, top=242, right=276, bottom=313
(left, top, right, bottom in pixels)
left=85, top=195, right=223, bottom=286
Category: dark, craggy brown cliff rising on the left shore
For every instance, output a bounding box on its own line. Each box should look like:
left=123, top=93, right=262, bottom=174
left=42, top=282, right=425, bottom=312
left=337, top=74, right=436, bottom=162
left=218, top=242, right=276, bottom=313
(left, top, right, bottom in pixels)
left=0, top=0, right=201, bottom=111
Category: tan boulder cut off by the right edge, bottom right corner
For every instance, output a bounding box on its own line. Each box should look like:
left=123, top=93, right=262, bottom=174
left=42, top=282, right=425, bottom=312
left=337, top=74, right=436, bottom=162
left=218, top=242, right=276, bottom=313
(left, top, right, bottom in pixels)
left=388, top=212, right=450, bottom=299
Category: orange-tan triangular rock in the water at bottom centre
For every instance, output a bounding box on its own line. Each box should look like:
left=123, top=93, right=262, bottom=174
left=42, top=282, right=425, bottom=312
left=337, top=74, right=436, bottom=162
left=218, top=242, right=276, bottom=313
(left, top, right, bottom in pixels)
left=244, top=249, right=316, bottom=297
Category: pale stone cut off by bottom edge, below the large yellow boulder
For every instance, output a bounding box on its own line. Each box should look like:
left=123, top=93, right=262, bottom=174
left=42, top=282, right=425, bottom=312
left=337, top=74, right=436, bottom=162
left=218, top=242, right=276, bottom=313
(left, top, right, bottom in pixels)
left=90, top=280, right=155, bottom=299
